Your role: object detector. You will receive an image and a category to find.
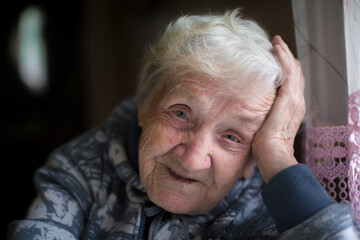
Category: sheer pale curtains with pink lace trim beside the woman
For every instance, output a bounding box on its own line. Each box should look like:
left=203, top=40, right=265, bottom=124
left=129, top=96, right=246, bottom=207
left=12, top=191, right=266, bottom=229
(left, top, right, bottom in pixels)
left=292, top=0, right=360, bottom=220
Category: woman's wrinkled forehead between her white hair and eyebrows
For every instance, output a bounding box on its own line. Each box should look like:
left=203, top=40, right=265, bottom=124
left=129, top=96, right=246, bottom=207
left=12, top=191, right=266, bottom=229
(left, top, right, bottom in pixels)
left=162, top=81, right=275, bottom=122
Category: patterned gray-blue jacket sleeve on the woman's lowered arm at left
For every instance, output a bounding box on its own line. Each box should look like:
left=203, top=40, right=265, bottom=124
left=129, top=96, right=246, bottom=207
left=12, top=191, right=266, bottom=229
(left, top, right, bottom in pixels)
left=7, top=130, right=101, bottom=239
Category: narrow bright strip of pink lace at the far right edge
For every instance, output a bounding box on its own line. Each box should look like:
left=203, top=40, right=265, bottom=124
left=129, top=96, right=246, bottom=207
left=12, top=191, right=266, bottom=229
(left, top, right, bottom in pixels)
left=348, top=91, right=360, bottom=221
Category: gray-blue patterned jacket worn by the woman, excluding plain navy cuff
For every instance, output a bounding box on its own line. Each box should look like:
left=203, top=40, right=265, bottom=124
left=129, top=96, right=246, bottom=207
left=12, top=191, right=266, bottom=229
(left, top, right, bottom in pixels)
left=8, top=100, right=357, bottom=240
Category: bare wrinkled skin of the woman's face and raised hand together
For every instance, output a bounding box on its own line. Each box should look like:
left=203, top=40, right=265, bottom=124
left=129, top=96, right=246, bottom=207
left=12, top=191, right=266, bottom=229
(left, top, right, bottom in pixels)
left=139, top=37, right=304, bottom=215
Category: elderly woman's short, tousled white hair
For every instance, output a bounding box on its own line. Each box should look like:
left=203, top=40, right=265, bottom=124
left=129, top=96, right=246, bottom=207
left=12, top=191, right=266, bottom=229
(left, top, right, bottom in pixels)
left=136, top=9, right=282, bottom=111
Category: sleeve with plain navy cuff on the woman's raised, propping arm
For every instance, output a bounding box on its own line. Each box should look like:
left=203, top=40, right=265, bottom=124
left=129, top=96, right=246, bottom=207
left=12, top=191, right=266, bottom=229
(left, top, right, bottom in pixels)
left=262, top=164, right=358, bottom=239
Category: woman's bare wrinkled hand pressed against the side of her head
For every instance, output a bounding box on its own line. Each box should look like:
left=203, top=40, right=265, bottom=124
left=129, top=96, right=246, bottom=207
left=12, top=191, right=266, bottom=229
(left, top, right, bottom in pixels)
left=252, top=36, right=305, bottom=182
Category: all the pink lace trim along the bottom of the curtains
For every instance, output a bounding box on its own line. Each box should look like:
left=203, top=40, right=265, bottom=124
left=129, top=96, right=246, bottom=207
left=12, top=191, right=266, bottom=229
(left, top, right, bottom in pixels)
left=305, top=91, right=360, bottom=221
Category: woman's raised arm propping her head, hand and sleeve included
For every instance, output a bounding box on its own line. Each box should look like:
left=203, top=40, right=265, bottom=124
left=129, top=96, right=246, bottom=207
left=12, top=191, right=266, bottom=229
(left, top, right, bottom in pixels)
left=252, top=36, right=358, bottom=239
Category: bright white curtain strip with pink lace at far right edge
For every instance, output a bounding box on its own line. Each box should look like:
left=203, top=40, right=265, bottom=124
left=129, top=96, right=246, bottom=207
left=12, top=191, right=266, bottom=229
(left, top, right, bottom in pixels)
left=343, top=0, right=360, bottom=220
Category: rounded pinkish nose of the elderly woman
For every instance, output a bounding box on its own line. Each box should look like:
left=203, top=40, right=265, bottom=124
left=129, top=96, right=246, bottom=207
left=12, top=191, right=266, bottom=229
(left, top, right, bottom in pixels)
left=174, top=131, right=212, bottom=171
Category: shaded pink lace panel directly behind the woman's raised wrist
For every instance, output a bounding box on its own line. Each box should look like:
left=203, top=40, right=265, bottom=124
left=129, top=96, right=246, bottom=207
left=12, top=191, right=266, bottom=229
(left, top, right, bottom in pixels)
left=305, top=126, right=349, bottom=202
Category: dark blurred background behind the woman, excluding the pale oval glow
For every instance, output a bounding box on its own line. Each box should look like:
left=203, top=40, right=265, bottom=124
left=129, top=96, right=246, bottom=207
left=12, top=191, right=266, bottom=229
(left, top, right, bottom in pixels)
left=0, top=0, right=295, bottom=238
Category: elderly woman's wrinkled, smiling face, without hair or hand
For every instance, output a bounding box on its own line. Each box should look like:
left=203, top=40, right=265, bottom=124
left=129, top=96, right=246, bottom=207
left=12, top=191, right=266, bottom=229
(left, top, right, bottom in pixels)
left=139, top=81, right=275, bottom=215
